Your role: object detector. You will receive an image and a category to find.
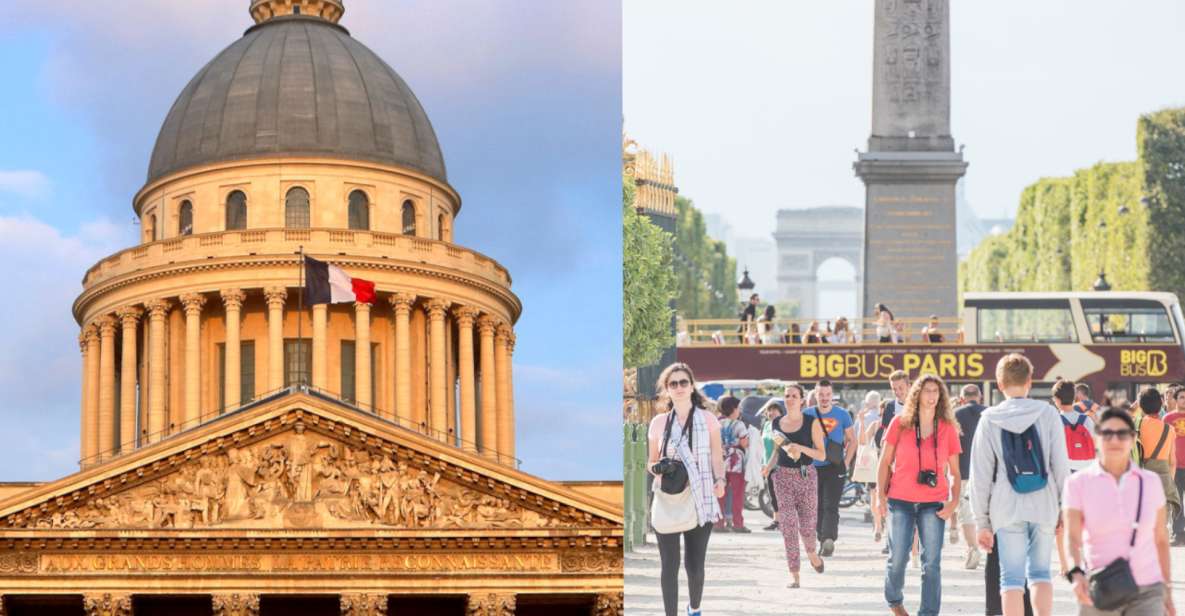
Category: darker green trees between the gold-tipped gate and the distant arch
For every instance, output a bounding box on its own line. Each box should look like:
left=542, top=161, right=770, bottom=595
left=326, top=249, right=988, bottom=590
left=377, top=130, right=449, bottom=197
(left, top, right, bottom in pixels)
left=675, top=197, right=737, bottom=319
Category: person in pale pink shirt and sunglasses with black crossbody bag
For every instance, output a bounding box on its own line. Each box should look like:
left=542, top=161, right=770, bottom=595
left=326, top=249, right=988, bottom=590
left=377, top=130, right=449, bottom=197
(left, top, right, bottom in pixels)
left=1062, top=409, right=1177, bottom=616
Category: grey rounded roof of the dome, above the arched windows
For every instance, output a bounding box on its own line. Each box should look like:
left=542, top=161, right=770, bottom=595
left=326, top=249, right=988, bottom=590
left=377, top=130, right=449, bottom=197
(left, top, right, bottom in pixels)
left=148, top=15, right=448, bottom=182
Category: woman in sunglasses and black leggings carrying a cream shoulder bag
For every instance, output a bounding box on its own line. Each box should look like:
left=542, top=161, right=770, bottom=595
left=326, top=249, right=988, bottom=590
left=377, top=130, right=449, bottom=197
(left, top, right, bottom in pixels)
left=647, top=362, right=725, bottom=616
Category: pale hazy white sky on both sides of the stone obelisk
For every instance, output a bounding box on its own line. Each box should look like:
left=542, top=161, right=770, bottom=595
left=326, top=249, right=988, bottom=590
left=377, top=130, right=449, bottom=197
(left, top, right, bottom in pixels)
left=623, top=0, right=1185, bottom=231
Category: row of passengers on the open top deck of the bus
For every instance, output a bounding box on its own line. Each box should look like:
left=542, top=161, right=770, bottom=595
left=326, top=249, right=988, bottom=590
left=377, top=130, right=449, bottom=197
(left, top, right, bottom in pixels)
left=712, top=294, right=963, bottom=345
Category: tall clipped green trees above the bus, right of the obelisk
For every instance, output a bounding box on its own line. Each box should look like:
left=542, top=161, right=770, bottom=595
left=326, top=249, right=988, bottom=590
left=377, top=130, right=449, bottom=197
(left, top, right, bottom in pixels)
left=960, top=109, right=1185, bottom=296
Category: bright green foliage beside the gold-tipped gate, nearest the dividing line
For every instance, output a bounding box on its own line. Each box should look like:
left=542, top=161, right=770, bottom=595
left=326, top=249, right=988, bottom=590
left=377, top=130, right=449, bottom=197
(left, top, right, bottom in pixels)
left=621, top=177, right=675, bottom=367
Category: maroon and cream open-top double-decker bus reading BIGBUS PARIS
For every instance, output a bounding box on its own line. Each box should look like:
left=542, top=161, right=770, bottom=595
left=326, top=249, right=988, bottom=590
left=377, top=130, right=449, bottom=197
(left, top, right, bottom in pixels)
left=677, top=291, right=1185, bottom=403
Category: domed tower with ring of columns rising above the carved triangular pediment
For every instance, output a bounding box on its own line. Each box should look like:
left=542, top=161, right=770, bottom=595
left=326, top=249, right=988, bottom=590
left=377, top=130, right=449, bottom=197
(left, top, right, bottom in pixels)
left=75, top=0, right=521, bottom=467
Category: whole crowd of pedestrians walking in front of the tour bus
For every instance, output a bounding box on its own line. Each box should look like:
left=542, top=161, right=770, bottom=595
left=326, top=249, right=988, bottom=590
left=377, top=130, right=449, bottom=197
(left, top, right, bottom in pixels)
left=649, top=354, right=1185, bottom=616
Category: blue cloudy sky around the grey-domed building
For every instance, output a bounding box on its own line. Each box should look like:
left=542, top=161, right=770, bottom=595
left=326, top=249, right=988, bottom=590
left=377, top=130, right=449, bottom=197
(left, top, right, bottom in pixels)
left=0, top=0, right=621, bottom=481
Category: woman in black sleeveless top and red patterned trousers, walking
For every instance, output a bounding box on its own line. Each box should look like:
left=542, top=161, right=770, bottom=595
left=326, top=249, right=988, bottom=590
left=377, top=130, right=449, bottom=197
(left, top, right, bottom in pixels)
left=762, top=383, right=827, bottom=589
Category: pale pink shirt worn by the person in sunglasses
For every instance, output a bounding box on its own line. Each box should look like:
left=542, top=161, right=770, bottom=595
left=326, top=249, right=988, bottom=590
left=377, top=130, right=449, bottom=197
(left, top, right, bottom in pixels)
left=1062, top=462, right=1165, bottom=586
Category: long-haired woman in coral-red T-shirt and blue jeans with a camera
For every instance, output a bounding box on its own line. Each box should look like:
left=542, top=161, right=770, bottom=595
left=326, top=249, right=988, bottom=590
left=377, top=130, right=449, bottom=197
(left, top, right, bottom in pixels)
left=877, top=374, right=962, bottom=616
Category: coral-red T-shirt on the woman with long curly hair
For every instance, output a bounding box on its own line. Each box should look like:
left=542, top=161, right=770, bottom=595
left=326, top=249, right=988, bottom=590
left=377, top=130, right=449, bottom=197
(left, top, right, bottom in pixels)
left=884, top=416, right=962, bottom=502
